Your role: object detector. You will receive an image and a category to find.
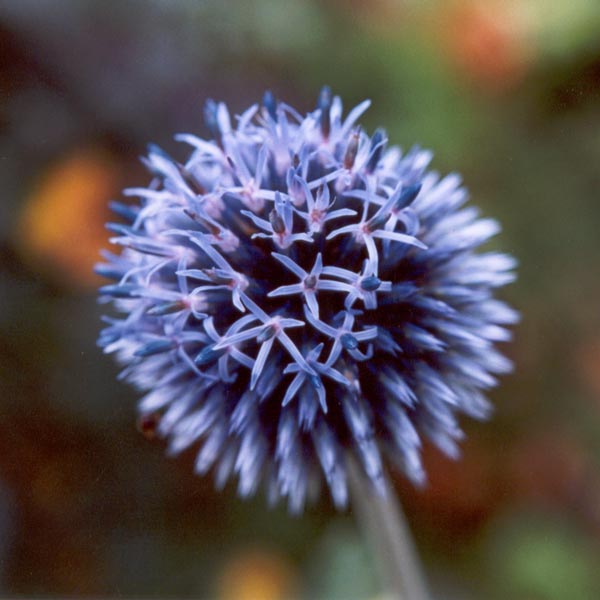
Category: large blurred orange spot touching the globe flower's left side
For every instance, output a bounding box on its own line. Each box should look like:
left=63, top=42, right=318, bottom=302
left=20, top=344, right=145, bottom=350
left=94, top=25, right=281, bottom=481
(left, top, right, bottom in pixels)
left=18, top=150, right=120, bottom=287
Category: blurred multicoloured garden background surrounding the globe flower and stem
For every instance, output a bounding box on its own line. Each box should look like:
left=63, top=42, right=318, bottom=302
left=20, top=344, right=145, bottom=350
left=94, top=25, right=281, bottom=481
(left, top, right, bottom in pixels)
left=0, top=0, right=600, bottom=600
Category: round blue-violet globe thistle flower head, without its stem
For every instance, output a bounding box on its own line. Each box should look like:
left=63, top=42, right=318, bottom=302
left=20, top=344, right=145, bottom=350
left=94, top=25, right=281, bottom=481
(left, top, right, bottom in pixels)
left=97, top=88, right=517, bottom=512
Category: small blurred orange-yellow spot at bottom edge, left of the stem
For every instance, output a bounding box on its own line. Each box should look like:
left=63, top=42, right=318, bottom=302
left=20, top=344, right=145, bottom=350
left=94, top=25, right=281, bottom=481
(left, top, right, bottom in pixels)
left=217, top=550, right=295, bottom=600
